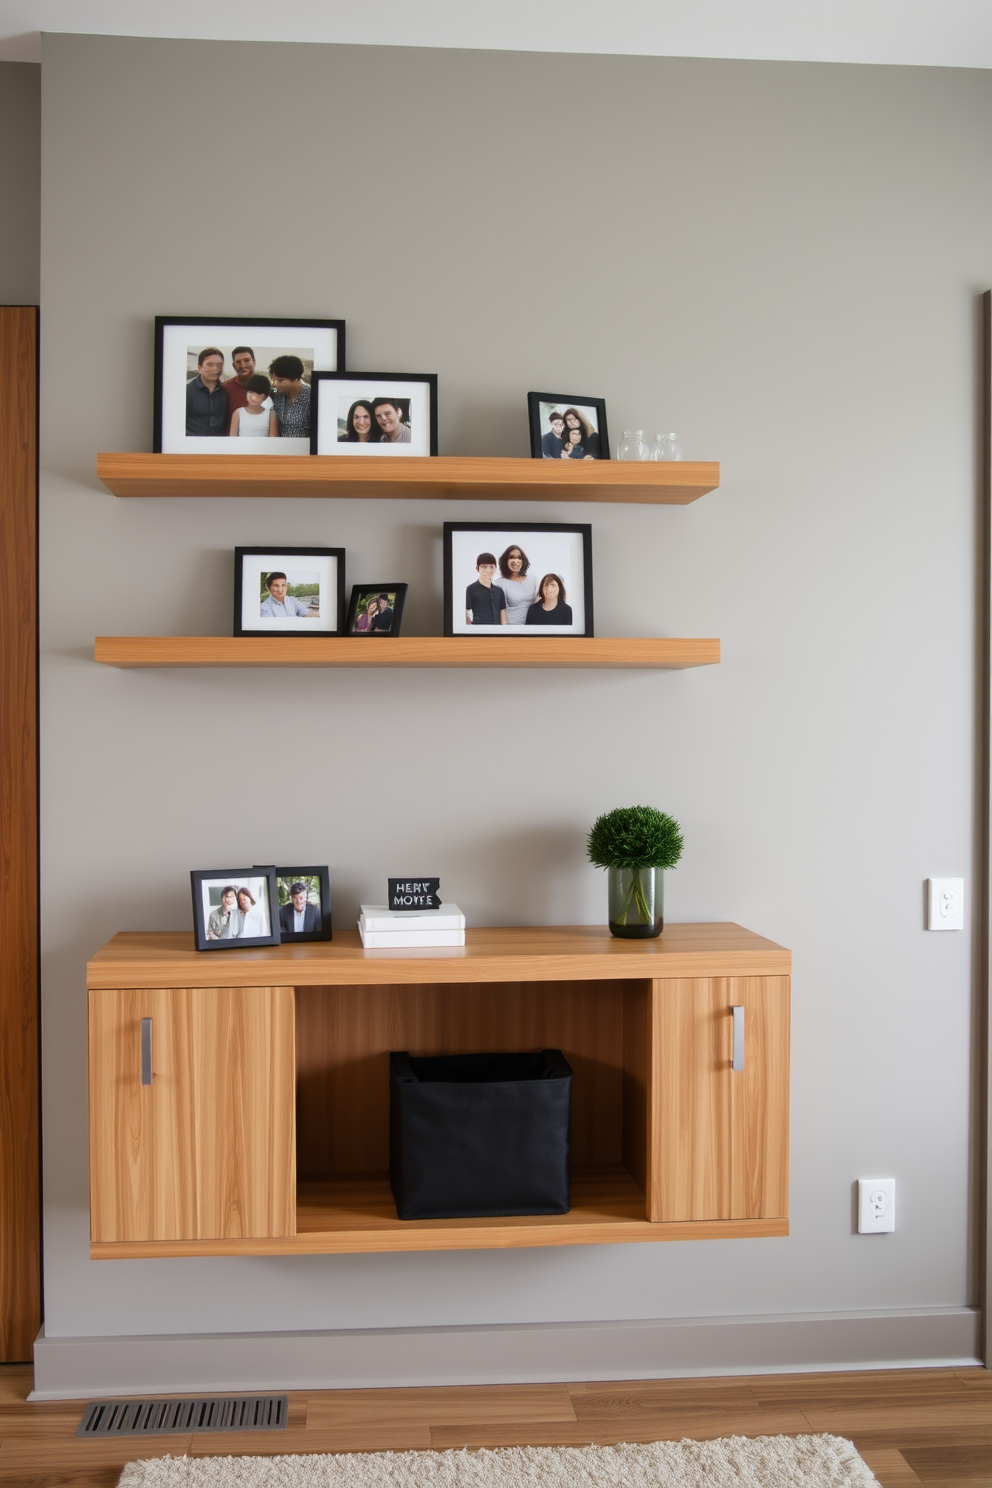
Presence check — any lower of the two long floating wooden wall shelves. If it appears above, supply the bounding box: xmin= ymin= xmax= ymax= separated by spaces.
xmin=94 ymin=635 xmax=720 ymax=670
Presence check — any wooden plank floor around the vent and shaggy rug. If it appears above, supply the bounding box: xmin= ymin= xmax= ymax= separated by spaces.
xmin=0 ymin=1366 xmax=992 ymax=1488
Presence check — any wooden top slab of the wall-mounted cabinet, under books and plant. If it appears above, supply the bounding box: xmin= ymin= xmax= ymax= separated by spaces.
xmin=86 ymin=923 xmax=791 ymax=990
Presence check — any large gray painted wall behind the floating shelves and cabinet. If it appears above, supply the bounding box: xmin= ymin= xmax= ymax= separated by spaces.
xmin=42 ymin=36 xmax=992 ymax=1363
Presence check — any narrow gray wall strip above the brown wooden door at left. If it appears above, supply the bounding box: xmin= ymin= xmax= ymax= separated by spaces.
xmin=0 ymin=62 xmax=42 ymax=305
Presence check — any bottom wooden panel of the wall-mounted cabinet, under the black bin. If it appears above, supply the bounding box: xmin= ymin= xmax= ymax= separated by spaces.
xmin=91 ymin=1167 xmax=788 ymax=1260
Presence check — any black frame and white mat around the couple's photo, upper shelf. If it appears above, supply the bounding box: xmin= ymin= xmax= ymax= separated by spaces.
xmin=309 ymin=369 xmax=437 ymax=458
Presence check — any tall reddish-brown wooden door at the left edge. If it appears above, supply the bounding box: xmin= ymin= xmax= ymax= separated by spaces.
xmin=0 ymin=305 xmax=42 ymax=1360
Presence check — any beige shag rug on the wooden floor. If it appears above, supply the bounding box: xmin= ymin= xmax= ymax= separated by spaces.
xmin=119 ymin=1436 xmax=876 ymax=1488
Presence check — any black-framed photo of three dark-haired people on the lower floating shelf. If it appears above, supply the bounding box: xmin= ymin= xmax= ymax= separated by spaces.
xmin=443 ymin=522 xmax=593 ymax=637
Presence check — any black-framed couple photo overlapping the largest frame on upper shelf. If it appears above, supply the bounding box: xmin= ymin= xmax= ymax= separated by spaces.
xmin=311 ymin=372 xmax=437 ymax=455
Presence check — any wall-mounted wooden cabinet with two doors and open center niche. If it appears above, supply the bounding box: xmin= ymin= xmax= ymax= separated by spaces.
xmin=89 ymin=924 xmax=790 ymax=1257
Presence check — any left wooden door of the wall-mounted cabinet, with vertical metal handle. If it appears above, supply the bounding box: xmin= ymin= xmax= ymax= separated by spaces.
xmin=89 ymin=987 xmax=296 ymax=1241
